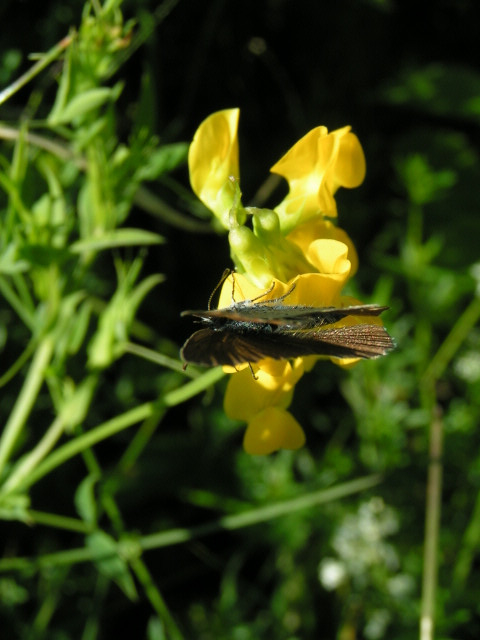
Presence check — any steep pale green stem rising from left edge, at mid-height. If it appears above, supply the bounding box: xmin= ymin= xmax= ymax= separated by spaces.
xmin=0 ymin=335 xmax=54 ymax=474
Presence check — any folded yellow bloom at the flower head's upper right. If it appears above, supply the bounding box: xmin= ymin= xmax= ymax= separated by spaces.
xmin=270 ymin=127 xmax=366 ymax=232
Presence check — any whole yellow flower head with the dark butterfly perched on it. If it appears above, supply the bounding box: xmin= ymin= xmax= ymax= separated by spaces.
xmin=188 ymin=109 xmax=381 ymax=454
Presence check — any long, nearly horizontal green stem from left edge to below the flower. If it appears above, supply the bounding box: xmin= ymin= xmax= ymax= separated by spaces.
xmin=0 ymin=475 xmax=382 ymax=572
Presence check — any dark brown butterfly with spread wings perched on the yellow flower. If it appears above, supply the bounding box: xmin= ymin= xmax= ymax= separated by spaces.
xmin=180 ymin=278 xmax=395 ymax=367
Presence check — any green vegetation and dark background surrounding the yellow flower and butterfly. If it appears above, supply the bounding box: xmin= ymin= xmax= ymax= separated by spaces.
xmin=0 ymin=0 xmax=480 ymax=640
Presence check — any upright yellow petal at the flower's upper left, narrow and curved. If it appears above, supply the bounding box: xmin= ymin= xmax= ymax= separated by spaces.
xmin=188 ymin=109 xmax=240 ymax=222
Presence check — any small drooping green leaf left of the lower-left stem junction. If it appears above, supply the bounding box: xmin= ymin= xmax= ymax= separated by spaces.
xmin=87 ymin=531 xmax=138 ymax=600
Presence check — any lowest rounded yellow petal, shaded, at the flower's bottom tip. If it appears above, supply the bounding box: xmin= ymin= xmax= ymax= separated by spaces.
xmin=243 ymin=407 xmax=305 ymax=455
